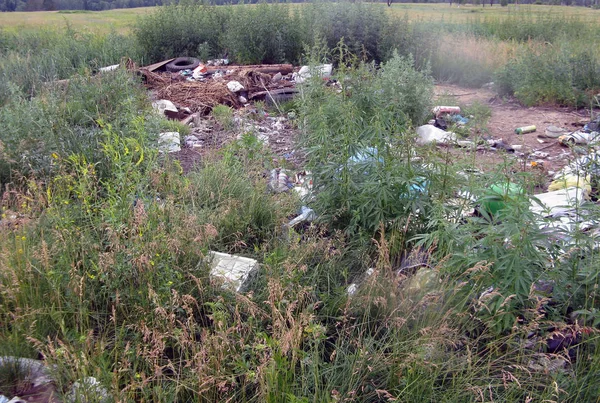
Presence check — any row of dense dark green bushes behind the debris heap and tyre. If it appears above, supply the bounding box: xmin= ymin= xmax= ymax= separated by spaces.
xmin=135 ymin=2 xmax=426 ymax=63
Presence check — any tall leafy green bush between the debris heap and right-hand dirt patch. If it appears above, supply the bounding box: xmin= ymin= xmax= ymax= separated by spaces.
xmin=301 ymin=55 xmax=431 ymax=237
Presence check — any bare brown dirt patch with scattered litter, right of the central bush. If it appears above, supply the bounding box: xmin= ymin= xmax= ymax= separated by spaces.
xmin=435 ymin=85 xmax=590 ymax=172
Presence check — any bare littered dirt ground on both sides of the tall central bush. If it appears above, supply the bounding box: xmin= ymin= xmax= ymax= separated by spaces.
xmin=172 ymin=85 xmax=590 ymax=174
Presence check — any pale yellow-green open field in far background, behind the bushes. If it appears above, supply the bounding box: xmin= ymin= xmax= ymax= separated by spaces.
xmin=0 ymin=3 xmax=600 ymax=33
